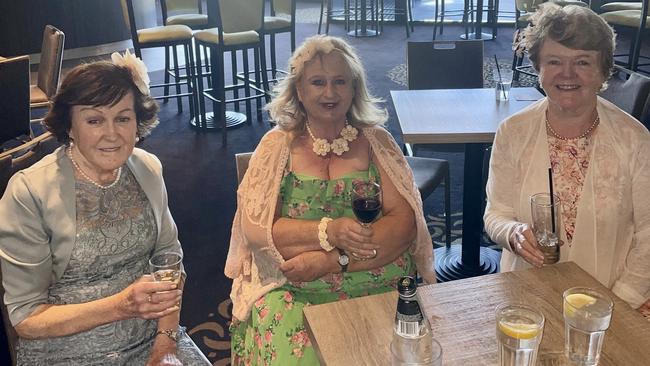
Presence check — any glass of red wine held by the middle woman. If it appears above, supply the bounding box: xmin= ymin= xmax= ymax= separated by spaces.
xmin=352 ymin=181 xmax=381 ymax=260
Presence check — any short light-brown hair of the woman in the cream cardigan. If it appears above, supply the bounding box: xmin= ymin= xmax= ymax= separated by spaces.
xmin=520 ymin=2 xmax=616 ymax=80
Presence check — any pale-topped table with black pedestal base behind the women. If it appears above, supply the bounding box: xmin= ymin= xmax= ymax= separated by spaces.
xmin=390 ymin=88 xmax=542 ymax=281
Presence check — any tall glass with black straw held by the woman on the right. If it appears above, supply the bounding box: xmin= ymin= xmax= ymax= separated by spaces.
xmin=530 ymin=193 xmax=560 ymax=264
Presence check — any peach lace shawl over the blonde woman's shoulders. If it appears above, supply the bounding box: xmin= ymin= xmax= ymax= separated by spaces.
xmin=225 ymin=127 xmax=435 ymax=321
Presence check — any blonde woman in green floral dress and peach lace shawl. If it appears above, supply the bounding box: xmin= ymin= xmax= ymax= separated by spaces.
xmin=225 ymin=36 xmax=435 ymax=366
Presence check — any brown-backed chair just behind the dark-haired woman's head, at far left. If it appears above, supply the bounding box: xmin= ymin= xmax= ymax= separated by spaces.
xmin=29 ymin=25 xmax=65 ymax=121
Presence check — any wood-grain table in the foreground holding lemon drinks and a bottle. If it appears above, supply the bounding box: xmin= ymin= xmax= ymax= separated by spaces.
xmin=304 ymin=262 xmax=650 ymax=366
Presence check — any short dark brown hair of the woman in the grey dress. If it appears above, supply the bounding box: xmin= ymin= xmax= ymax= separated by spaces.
xmin=44 ymin=61 xmax=158 ymax=145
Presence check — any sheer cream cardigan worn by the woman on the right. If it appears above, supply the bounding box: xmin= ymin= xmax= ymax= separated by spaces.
xmin=484 ymin=98 xmax=650 ymax=308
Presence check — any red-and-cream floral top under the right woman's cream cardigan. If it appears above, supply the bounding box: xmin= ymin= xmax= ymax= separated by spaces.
xmin=548 ymin=134 xmax=593 ymax=246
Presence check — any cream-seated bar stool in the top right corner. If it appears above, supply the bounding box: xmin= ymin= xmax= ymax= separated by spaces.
xmin=600 ymin=1 xmax=650 ymax=73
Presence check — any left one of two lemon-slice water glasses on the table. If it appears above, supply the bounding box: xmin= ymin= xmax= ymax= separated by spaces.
xmin=496 ymin=303 xmax=544 ymax=366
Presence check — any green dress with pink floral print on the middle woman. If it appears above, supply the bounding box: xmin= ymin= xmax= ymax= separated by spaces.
xmin=230 ymin=164 xmax=415 ymax=366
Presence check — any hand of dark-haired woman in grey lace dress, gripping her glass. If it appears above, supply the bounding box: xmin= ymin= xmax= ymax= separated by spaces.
xmin=117 ymin=275 xmax=182 ymax=319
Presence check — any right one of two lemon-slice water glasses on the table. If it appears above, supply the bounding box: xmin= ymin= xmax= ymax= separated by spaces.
xmin=563 ymin=287 xmax=614 ymax=365
